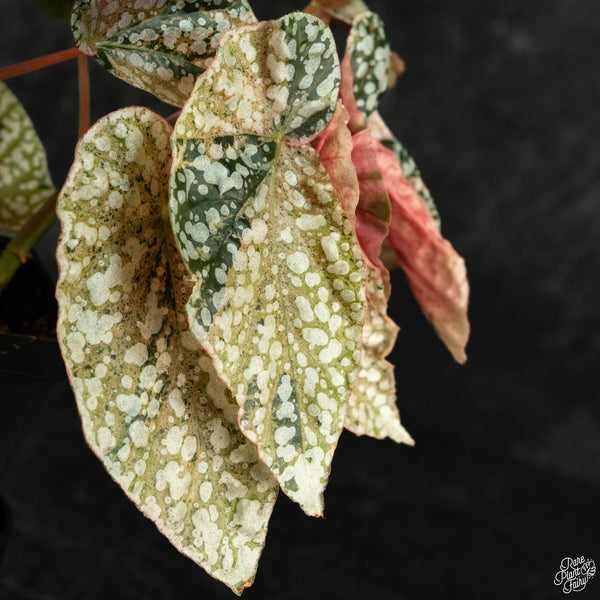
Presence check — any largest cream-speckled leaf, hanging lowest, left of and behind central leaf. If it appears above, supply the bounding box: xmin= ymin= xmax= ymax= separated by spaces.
xmin=57 ymin=108 xmax=277 ymax=593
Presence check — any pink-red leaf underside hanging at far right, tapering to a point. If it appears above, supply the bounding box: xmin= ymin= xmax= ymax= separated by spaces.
xmin=376 ymin=142 xmax=470 ymax=363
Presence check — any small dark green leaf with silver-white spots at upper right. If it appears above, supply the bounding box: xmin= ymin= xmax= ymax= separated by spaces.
xmin=345 ymin=11 xmax=392 ymax=117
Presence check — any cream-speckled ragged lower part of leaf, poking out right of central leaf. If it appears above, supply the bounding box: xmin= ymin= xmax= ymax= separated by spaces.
xmin=345 ymin=265 xmax=414 ymax=446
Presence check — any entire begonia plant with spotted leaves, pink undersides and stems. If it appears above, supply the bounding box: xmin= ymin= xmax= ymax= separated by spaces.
xmin=0 ymin=0 xmax=469 ymax=594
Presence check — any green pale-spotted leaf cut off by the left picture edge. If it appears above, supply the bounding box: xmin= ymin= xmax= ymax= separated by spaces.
xmin=0 ymin=81 xmax=54 ymax=232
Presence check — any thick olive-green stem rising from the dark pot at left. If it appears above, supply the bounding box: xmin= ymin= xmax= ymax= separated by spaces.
xmin=0 ymin=191 xmax=58 ymax=294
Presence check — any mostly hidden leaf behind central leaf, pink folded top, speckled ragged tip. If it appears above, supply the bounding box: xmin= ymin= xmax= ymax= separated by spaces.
xmin=313 ymin=110 xmax=413 ymax=444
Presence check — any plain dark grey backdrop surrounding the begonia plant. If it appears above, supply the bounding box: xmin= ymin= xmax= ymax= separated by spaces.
xmin=0 ymin=0 xmax=600 ymax=600
